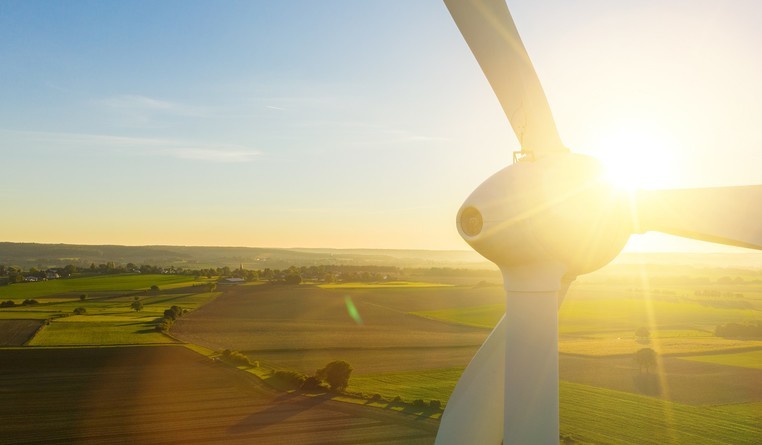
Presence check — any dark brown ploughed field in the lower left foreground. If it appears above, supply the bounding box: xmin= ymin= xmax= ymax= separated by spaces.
xmin=0 ymin=346 xmax=437 ymax=444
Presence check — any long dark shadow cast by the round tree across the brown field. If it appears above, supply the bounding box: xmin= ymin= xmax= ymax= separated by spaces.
xmin=228 ymin=393 xmax=331 ymax=434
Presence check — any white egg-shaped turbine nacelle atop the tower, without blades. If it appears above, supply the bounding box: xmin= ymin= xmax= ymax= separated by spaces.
xmin=457 ymin=153 xmax=633 ymax=278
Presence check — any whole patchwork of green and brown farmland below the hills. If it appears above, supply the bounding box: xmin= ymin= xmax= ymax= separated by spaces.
xmin=0 ymin=262 xmax=762 ymax=444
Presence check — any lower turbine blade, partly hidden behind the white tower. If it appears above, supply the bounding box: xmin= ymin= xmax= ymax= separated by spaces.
xmin=435 ymin=316 xmax=506 ymax=445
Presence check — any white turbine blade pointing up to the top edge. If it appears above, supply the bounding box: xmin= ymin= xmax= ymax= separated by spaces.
xmin=444 ymin=0 xmax=569 ymax=155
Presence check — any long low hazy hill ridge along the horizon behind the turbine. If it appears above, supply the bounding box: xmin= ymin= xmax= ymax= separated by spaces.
xmin=0 ymin=242 xmax=762 ymax=269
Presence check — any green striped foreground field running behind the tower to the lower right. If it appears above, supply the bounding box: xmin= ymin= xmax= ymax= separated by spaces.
xmin=352 ymin=369 xmax=762 ymax=445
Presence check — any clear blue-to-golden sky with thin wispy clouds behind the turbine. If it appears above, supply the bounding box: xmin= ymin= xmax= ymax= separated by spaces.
xmin=0 ymin=0 xmax=762 ymax=250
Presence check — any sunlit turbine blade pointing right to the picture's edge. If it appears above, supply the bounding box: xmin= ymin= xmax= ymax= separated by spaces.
xmin=634 ymin=185 xmax=762 ymax=250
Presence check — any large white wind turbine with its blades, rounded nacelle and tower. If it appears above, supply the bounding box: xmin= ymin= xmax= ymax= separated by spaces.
xmin=436 ymin=0 xmax=762 ymax=445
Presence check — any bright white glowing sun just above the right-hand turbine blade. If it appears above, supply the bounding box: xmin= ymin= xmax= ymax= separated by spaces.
xmin=595 ymin=120 xmax=675 ymax=190
